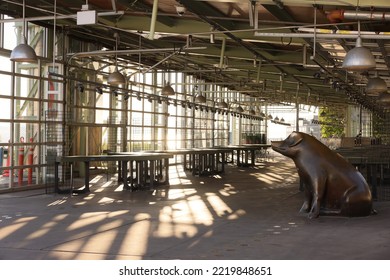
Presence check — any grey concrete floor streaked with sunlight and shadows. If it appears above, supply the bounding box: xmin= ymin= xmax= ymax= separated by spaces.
xmin=0 ymin=157 xmax=390 ymax=260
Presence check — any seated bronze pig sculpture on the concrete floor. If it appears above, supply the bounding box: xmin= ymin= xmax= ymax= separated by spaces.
xmin=271 ymin=132 xmax=375 ymax=218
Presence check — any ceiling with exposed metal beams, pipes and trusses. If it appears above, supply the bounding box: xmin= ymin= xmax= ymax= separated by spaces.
xmin=0 ymin=0 xmax=390 ymax=114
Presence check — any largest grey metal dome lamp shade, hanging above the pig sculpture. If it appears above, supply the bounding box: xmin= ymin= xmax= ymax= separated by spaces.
xmin=342 ymin=37 xmax=376 ymax=72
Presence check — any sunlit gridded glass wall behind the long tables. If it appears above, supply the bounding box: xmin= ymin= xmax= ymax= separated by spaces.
xmin=0 ymin=14 xmax=263 ymax=190
